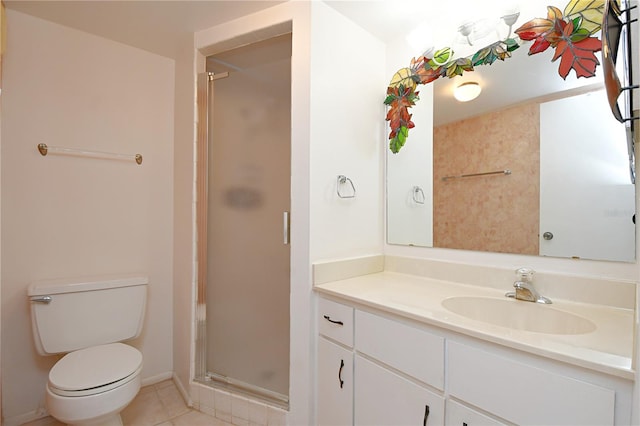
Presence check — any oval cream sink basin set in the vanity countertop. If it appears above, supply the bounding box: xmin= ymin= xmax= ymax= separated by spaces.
xmin=442 ymin=296 xmax=596 ymax=334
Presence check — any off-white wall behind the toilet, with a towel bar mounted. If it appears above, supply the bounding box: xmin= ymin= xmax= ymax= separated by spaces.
xmin=2 ymin=10 xmax=174 ymax=424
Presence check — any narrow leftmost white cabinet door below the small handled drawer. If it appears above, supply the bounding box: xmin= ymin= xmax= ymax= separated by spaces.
xmin=318 ymin=337 xmax=353 ymax=426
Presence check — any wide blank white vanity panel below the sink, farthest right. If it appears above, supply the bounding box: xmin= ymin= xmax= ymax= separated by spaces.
xmin=447 ymin=341 xmax=615 ymax=425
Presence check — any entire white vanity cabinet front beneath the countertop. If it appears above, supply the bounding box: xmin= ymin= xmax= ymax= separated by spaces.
xmin=318 ymin=297 xmax=633 ymax=426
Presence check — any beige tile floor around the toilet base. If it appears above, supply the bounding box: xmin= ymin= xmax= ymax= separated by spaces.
xmin=25 ymin=380 xmax=233 ymax=426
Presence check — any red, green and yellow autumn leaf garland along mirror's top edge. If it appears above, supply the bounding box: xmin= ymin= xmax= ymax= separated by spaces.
xmin=384 ymin=0 xmax=604 ymax=154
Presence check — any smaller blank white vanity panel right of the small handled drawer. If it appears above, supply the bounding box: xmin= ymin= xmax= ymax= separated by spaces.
xmin=355 ymin=310 xmax=444 ymax=390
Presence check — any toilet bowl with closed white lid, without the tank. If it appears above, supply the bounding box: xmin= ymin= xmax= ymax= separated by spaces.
xmin=46 ymin=343 xmax=142 ymax=426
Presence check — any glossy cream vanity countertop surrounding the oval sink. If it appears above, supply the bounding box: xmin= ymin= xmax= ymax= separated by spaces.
xmin=314 ymin=271 xmax=634 ymax=380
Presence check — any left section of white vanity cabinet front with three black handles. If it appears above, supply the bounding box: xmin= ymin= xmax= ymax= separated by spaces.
xmin=317 ymin=298 xmax=444 ymax=426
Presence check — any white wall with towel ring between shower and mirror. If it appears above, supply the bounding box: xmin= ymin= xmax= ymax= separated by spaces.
xmin=308 ymin=2 xmax=386 ymax=262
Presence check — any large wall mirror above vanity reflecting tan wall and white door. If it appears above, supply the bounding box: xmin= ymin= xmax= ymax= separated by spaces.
xmin=387 ymin=0 xmax=635 ymax=262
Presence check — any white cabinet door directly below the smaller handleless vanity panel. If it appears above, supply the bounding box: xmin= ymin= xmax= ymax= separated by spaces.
xmin=354 ymin=355 xmax=444 ymax=426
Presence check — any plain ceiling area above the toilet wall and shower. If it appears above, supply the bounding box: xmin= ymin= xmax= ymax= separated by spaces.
xmin=4 ymin=0 xmax=284 ymax=58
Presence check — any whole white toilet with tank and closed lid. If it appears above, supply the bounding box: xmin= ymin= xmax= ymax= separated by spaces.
xmin=27 ymin=275 xmax=149 ymax=426
